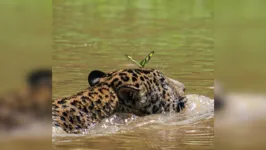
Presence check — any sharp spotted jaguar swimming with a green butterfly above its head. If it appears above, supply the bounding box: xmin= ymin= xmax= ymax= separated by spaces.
xmin=52 ymin=69 xmax=187 ymax=133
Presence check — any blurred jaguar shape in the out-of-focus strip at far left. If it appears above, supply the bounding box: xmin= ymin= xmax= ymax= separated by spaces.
xmin=0 ymin=68 xmax=52 ymax=132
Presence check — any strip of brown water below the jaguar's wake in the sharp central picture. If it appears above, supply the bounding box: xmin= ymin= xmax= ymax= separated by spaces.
xmin=53 ymin=120 xmax=214 ymax=150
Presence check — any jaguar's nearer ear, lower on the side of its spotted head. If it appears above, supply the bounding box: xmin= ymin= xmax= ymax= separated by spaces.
xmin=117 ymin=86 xmax=139 ymax=101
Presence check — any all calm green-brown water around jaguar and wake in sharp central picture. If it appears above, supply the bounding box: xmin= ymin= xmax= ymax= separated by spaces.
xmin=53 ymin=0 xmax=214 ymax=150
